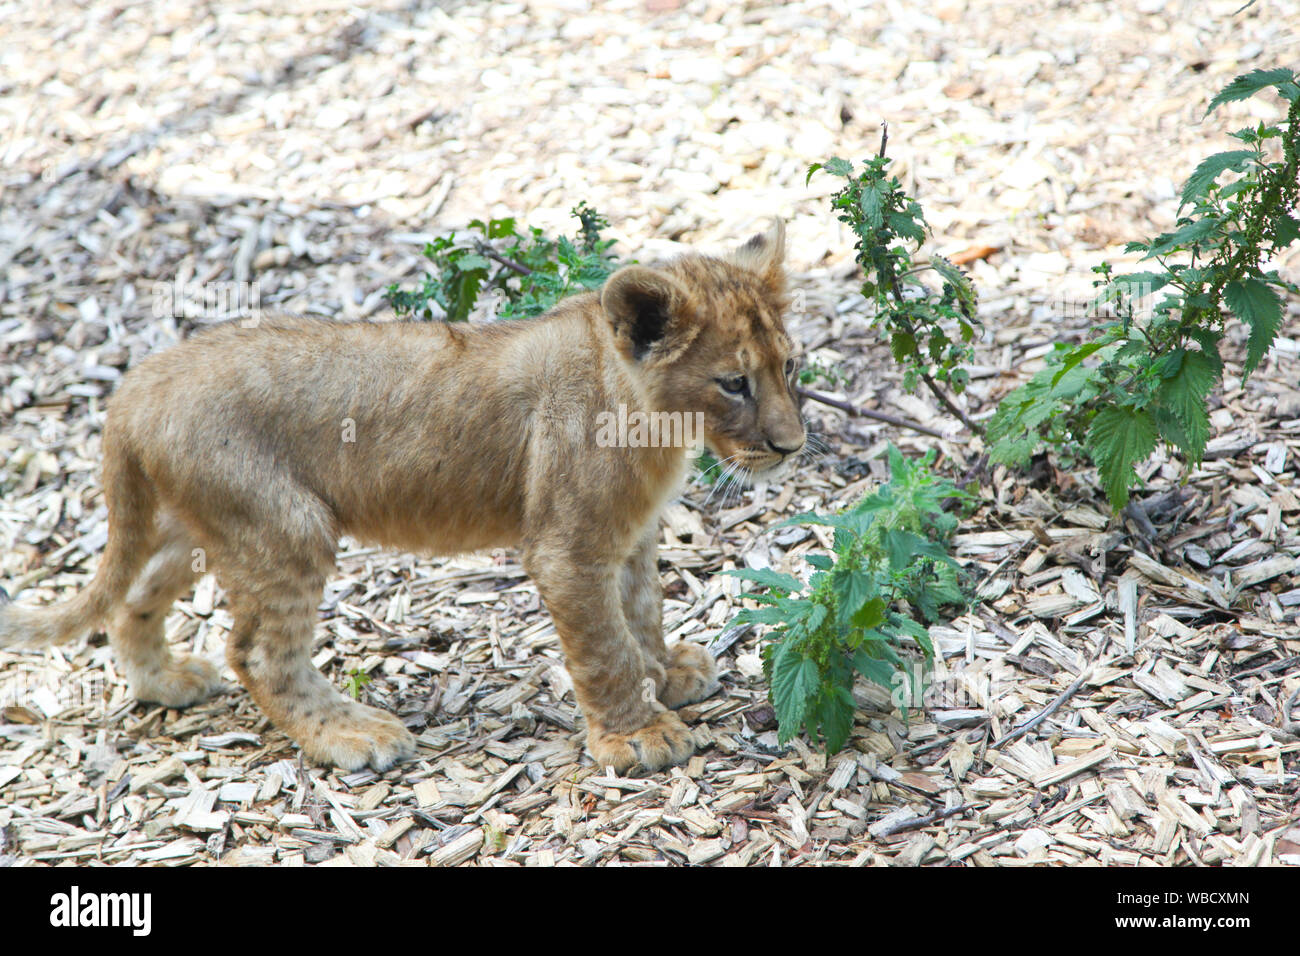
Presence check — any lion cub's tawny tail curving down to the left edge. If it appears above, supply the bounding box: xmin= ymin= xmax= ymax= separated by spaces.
xmin=0 ymin=433 xmax=157 ymax=648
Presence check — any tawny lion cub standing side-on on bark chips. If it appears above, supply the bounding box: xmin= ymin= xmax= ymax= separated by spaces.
xmin=0 ymin=225 xmax=805 ymax=771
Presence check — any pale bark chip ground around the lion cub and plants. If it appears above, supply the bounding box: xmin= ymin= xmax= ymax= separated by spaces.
xmin=0 ymin=0 xmax=1300 ymax=866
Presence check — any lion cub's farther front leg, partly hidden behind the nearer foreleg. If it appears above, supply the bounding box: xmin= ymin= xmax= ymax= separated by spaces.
xmin=620 ymin=524 xmax=718 ymax=708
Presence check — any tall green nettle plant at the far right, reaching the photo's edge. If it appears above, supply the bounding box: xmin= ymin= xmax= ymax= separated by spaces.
xmin=985 ymin=69 xmax=1300 ymax=511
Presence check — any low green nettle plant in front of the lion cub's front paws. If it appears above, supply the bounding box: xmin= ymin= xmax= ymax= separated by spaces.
xmin=727 ymin=445 xmax=966 ymax=753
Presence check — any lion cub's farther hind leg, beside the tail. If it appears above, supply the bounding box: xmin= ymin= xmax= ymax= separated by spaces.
xmin=108 ymin=512 xmax=221 ymax=708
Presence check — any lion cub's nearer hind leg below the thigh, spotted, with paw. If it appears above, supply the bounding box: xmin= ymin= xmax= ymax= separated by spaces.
xmin=217 ymin=535 xmax=415 ymax=771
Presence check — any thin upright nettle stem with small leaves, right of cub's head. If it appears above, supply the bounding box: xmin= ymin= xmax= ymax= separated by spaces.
xmin=807 ymin=152 xmax=979 ymax=431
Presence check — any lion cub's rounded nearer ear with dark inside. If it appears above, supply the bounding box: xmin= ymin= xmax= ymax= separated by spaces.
xmin=601 ymin=265 xmax=699 ymax=362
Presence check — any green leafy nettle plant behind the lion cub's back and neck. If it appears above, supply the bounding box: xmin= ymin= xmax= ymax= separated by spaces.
xmin=385 ymin=202 xmax=621 ymax=323
